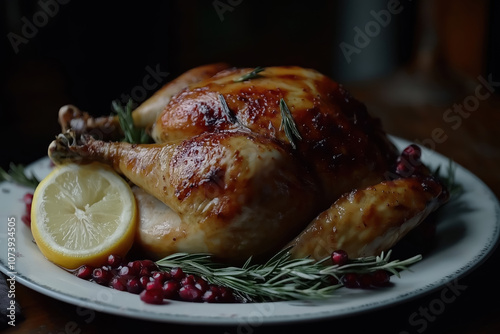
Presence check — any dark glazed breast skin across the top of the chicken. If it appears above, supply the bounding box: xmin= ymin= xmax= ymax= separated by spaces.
xmin=152 ymin=66 xmax=396 ymax=205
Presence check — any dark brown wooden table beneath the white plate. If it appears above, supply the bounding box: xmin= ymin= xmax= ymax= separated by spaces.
xmin=1 ymin=72 xmax=500 ymax=334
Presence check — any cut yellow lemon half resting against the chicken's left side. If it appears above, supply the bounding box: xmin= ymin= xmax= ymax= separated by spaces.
xmin=31 ymin=163 xmax=137 ymax=269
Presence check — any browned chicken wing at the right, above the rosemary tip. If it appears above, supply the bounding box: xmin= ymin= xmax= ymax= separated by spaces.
xmin=289 ymin=177 xmax=447 ymax=260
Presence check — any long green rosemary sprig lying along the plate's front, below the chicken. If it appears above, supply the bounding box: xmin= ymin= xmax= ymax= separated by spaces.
xmin=157 ymin=249 xmax=422 ymax=302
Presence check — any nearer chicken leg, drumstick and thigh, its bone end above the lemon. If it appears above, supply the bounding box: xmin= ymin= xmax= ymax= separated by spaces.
xmin=50 ymin=131 xmax=319 ymax=262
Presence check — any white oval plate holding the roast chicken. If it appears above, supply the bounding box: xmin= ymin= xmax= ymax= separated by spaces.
xmin=0 ymin=138 xmax=500 ymax=325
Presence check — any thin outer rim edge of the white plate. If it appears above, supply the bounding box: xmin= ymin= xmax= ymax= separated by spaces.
xmin=0 ymin=135 xmax=500 ymax=325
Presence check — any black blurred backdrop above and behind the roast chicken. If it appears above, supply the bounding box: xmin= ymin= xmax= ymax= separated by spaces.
xmin=0 ymin=0 xmax=499 ymax=168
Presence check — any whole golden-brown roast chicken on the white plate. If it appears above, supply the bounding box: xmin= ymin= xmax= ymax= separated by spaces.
xmin=49 ymin=64 xmax=448 ymax=263
